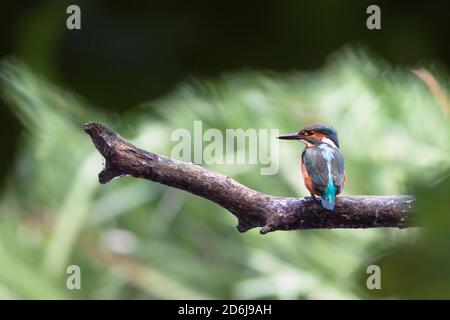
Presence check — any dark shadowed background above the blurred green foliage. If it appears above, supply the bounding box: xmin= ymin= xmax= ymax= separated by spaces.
xmin=0 ymin=0 xmax=450 ymax=185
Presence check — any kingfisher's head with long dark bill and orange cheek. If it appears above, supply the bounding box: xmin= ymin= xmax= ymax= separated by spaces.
xmin=278 ymin=124 xmax=339 ymax=148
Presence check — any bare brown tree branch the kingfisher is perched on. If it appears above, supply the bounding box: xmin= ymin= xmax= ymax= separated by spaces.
xmin=84 ymin=123 xmax=414 ymax=234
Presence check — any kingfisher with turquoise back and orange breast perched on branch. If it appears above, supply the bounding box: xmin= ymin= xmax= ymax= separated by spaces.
xmin=278 ymin=124 xmax=346 ymax=211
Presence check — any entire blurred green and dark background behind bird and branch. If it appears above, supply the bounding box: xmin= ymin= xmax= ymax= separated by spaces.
xmin=0 ymin=0 xmax=450 ymax=299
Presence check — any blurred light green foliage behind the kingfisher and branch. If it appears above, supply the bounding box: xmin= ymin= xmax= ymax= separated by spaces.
xmin=0 ymin=50 xmax=450 ymax=299
